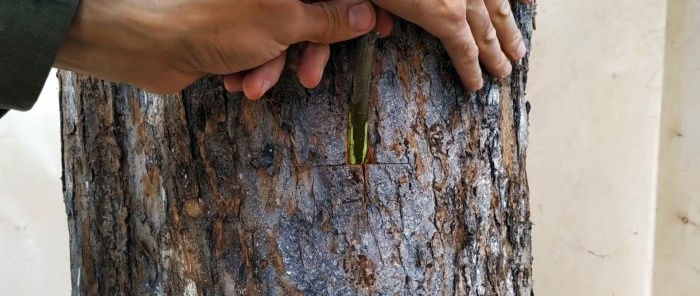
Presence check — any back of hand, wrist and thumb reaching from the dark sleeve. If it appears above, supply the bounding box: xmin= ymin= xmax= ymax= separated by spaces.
xmin=55 ymin=0 xmax=376 ymax=93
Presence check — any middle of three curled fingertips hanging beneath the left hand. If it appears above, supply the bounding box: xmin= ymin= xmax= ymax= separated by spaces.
xmin=241 ymin=52 xmax=286 ymax=100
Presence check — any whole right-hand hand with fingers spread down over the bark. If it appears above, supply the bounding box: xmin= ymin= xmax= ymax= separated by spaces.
xmin=372 ymin=0 xmax=533 ymax=90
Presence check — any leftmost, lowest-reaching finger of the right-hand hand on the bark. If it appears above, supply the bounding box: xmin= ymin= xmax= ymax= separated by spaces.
xmin=441 ymin=24 xmax=484 ymax=90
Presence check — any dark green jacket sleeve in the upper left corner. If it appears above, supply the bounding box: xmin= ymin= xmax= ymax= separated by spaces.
xmin=0 ymin=0 xmax=79 ymax=116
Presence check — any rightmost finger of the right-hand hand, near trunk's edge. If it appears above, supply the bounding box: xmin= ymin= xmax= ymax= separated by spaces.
xmin=484 ymin=0 xmax=527 ymax=61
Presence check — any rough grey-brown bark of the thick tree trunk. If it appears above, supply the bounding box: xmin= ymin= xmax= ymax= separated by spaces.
xmin=59 ymin=5 xmax=533 ymax=296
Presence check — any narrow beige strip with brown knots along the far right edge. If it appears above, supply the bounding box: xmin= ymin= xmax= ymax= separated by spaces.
xmin=654 ymin=0 xmax=700 ymax=296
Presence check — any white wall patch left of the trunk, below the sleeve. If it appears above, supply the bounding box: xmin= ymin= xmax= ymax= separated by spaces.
xmin=0 ymin=73 xmax=70 ymax=296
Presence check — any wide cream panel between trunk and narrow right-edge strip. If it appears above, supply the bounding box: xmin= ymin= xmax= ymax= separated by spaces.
xmin=527 ymin=0 xmax=666 ymax=296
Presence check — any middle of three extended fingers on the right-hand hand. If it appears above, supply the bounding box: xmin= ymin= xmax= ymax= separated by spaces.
xmin=467 ymin=0 xmax=512 ymax=78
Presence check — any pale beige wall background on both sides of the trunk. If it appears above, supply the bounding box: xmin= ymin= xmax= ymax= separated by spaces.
xmin=0 ymin=0 xmax=700 ymax=296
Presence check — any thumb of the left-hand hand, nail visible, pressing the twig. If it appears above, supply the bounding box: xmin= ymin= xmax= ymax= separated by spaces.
xmin=297 ymin=0 xmax=376 ymax=44
